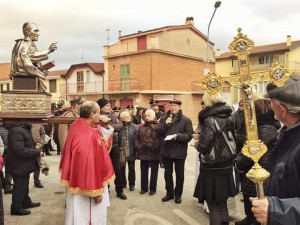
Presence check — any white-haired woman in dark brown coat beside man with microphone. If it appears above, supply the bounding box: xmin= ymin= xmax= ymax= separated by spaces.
xmin=134 ymin=109 xmax=161 ymax=195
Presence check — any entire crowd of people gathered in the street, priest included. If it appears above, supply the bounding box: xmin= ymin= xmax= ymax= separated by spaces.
xmin=0 ymin=76 xmax=300 ymax=225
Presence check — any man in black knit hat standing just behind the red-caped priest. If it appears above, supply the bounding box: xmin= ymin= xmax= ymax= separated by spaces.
xmin=97 ymin=98 xmax=127 ymax=200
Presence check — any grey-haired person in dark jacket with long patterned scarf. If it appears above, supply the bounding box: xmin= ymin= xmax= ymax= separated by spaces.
xmin=118 ymin=111 xmax=137 ymax=191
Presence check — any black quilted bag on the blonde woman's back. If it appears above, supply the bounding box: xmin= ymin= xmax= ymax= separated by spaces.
xmin=201 ymin=118 xmax=236 ymax=164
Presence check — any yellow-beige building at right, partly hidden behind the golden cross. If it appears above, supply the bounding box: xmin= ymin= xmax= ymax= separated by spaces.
xmin=216 ymin=35 xmax=300 ymax=104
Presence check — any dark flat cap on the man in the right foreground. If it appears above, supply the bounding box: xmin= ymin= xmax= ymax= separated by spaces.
xmin=264 ymin=75 xmax=300 ymax=105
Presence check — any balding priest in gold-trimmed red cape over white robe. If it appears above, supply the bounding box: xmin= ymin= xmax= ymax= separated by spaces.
xmin=59 ymin=101 xmax=114 ymax=225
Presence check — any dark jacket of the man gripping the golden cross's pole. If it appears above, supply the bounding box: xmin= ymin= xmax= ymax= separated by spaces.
xmin=265 ymin=120 xmax=300 ymax=225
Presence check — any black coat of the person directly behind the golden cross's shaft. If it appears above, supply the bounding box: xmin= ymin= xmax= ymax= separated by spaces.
xmin=236 ymin=111 xmax=280 ymax=197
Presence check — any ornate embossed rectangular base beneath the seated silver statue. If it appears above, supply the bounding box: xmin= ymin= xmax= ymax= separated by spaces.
xmin=0 ymin=90 xmax=53 ymax=124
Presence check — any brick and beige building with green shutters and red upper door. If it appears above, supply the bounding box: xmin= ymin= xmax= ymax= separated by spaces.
xmin=103 ymin=17 xmax=215 ymax=124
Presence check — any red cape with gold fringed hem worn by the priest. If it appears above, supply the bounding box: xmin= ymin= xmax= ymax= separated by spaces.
xmin=59 ymin=118 xmax=114 ymax=197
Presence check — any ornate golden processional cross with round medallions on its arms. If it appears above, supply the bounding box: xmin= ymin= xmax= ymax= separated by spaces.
xmin=201 ymin=28 xmax=290 ymax=199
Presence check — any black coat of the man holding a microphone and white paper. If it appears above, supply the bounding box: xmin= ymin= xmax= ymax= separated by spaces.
xmin=156 ymin=110 xmax=193 ymax=159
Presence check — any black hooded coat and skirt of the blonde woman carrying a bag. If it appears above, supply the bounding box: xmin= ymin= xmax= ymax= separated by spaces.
xmin=193 ymin=103 xmax=237 ymax=203
